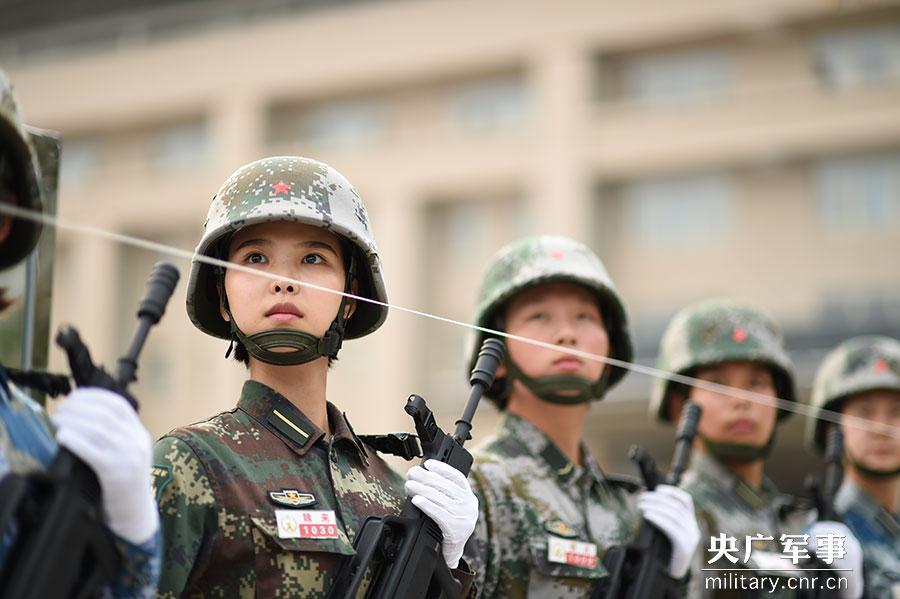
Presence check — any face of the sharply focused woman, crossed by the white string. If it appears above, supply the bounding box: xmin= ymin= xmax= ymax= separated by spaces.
xmin=223 ymin=222 xmax=353 ymax=351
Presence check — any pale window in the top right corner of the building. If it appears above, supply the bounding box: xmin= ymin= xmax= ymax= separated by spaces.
xmin=813 ymin=25 xmax=900 ymax=90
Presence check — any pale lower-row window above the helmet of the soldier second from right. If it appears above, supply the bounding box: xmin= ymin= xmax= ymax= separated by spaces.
xmin=623 ymin=174 xmax=734 ymax=246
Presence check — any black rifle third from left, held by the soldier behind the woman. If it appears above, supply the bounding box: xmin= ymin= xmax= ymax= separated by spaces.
xmin=592 ymin=402 xmax=700 ymax=599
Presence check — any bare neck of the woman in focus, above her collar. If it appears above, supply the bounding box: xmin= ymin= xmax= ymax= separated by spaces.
xmin=250 ymin=357 xmax=331 ymax=437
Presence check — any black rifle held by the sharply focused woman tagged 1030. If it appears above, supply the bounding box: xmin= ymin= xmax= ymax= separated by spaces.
xmin=330 ymin=339 xmax=504 ymax=599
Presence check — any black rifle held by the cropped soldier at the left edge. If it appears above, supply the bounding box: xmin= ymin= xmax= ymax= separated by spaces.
xmin=0 ymin=262 xmax=179 ymax=599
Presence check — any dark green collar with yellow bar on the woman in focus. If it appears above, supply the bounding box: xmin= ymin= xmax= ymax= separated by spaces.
xmin=238 ymin=380 xmax=368 ymax=465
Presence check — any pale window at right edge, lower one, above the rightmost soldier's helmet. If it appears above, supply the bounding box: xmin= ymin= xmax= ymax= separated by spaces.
xmin=813 ymin=152 xmax=900 ymax=230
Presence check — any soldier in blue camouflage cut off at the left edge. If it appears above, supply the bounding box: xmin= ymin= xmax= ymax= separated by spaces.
xmin=0 ymin=71 xmax=160 ymax=597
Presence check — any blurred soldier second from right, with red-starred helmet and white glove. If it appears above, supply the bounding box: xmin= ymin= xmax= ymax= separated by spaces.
xmin=650 ymin=300 xmax=862 ymax=599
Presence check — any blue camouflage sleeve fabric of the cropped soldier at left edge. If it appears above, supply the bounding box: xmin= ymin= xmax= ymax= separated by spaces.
xmin=0 ymin=367 xmax=162 ymax=598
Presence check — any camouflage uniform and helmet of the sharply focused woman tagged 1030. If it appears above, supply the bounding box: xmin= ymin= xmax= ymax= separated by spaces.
xmin=154 ymin=156 xmax=472 ymax=597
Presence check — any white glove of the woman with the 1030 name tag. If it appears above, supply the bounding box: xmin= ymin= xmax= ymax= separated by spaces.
xmin=406 ymin=460 xmax=478 ymax=568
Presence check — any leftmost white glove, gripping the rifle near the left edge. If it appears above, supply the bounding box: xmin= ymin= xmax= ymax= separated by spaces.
xmin=52 ymin=387 xmax=159 ymax=545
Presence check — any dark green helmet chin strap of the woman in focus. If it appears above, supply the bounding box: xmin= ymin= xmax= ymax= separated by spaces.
xmin=219 ymin=252 xmax=356 ymax=366
